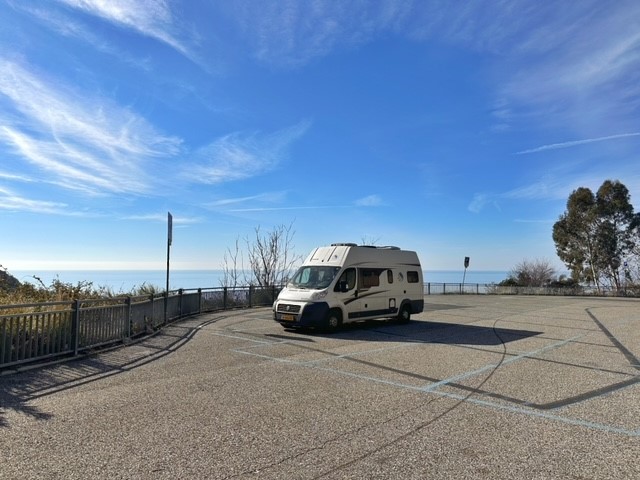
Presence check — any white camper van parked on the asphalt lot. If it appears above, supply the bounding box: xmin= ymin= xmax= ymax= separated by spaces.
xmin=273 ymin=243 xmax=424 ymax=329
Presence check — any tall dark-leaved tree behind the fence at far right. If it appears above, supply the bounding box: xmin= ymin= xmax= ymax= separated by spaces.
xmin=553 ymin=180 xmax=640 ymax=290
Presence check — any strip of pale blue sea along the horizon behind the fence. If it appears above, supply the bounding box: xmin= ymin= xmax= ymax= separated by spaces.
xmin=9 ymin=269 xmax=509 ymax=294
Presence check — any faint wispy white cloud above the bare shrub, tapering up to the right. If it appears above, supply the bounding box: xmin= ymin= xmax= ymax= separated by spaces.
xmin=185 ymin=121 xmax=310 ymax=184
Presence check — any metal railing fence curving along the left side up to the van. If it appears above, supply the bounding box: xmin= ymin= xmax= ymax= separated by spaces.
xmin=0 ymin=287 xmax=279 ymax=369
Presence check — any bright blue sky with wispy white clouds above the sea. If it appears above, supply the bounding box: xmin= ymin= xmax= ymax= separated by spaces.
xmin=0 ymin=0 xmax=640 ymax=274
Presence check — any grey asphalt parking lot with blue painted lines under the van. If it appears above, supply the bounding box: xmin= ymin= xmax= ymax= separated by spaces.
xmin=0 ymin=295 xmax=640 ymax=479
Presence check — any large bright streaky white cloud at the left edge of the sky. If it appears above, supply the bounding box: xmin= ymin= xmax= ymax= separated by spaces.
xmin=0 ymin=59 xmax=181 ymax=194
